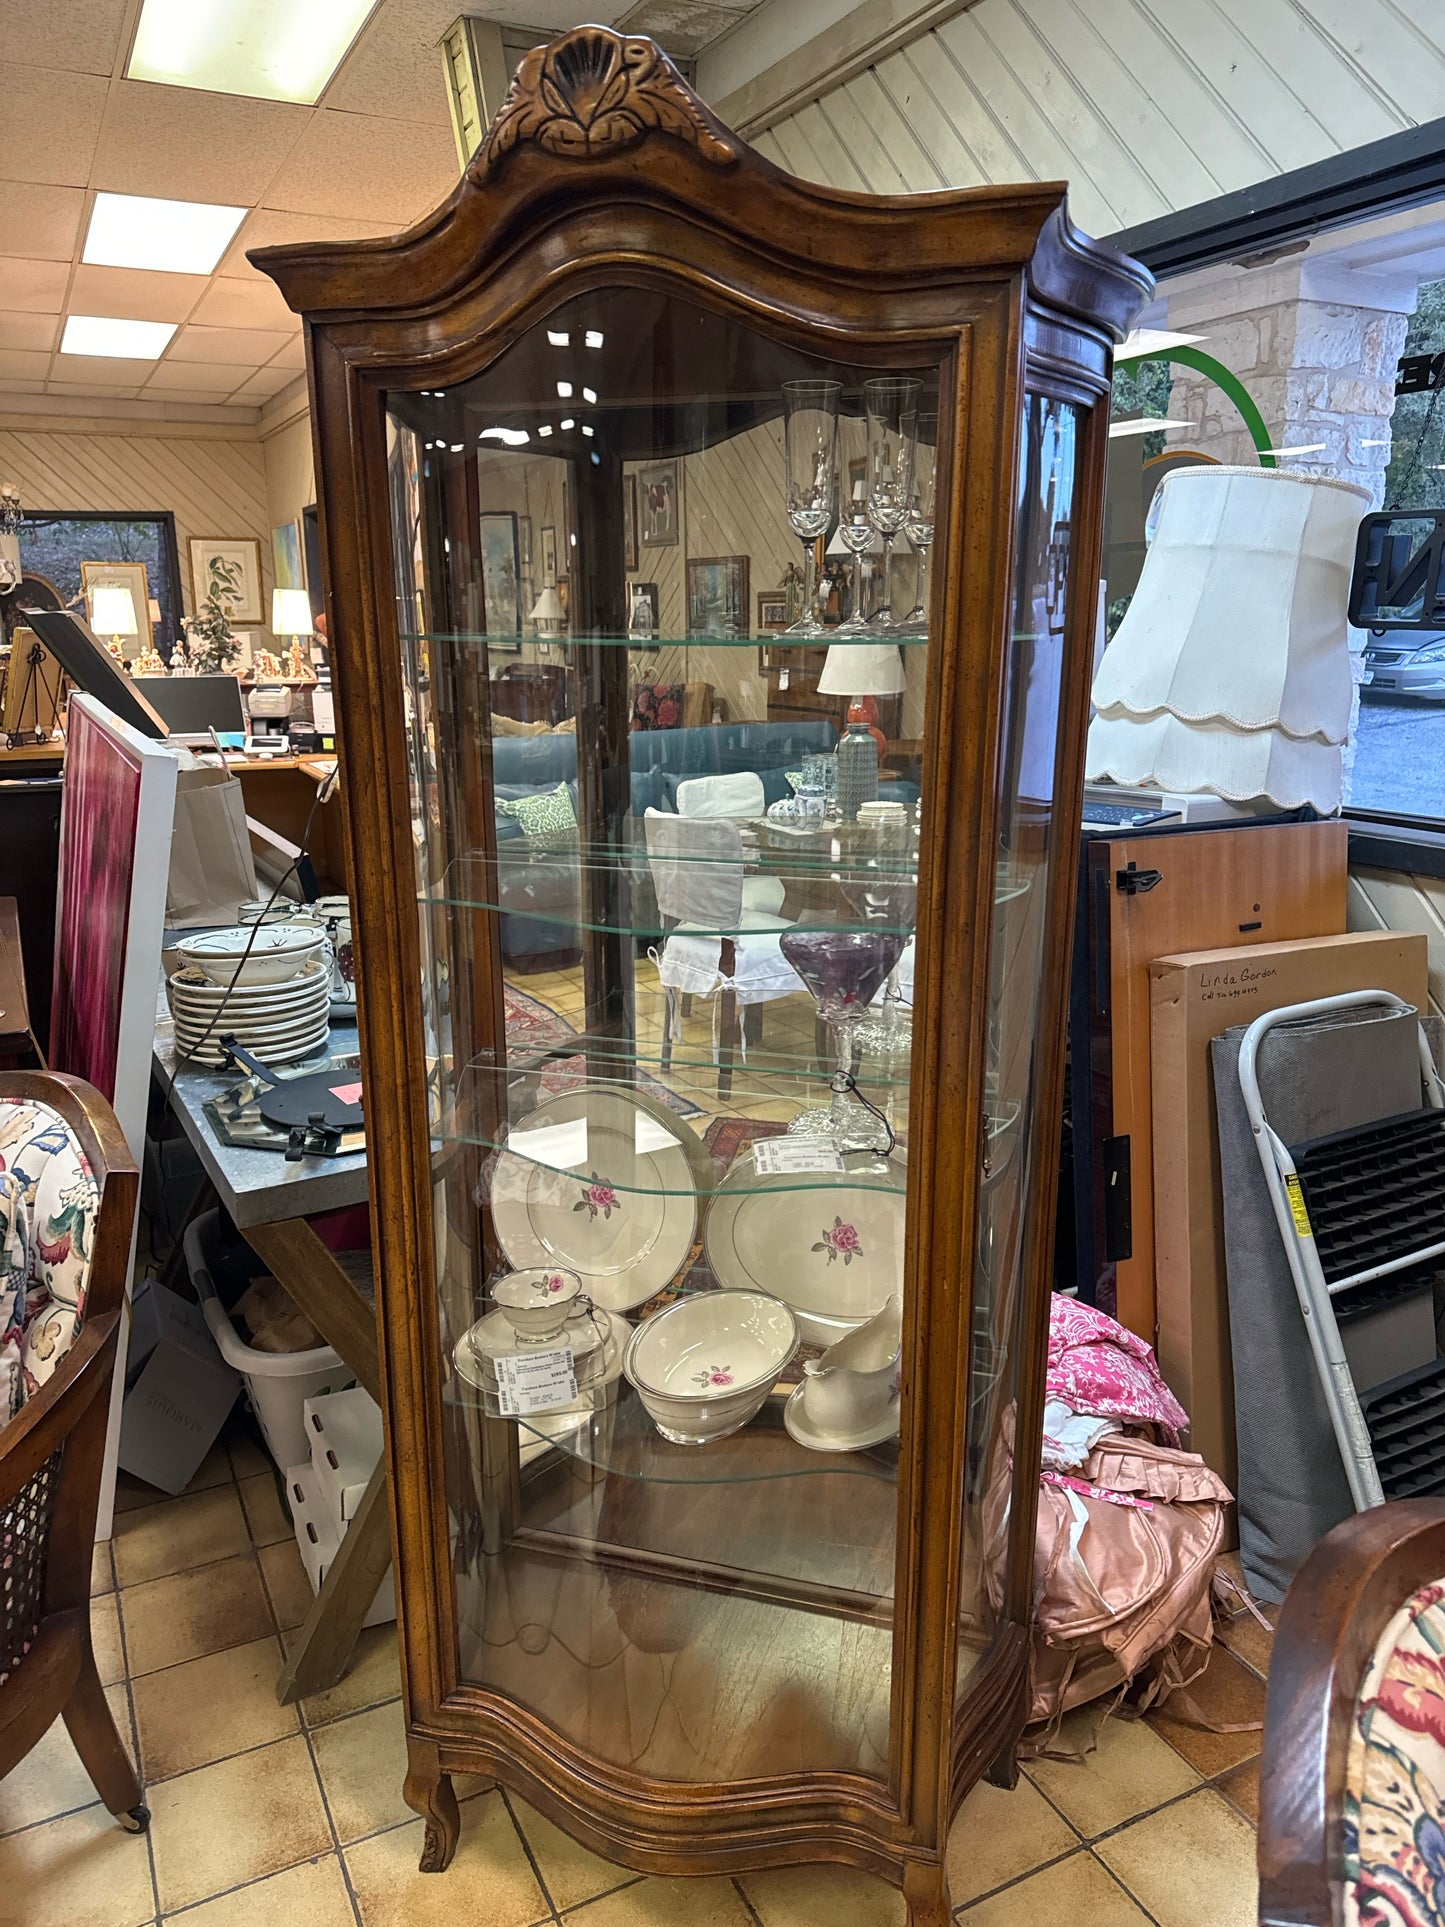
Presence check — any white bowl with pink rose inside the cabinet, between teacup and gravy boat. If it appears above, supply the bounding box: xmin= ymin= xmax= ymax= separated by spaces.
xmin=622 ymin=1291 xmax=798 ymax=1445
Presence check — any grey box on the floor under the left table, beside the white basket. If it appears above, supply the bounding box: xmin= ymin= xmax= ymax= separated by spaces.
xmin=119 ymin=1278 xmax=241 ymax=1493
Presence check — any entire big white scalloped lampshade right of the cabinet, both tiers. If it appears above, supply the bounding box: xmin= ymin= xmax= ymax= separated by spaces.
xmin=1087 ymin=464 xmax=1370 ymax=811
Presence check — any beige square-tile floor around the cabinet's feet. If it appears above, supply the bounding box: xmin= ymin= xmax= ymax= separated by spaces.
xmin=0 ymin=1420 xmax=1268 ymax=1927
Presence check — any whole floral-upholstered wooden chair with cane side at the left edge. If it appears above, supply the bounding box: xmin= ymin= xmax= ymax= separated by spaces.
xmin=0 ymin=1071 xmax=150 ymax=1833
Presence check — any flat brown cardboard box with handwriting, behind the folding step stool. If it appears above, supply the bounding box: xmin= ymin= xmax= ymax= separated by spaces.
xmin=1150 ymin=931 xmax=1430 ymax=1490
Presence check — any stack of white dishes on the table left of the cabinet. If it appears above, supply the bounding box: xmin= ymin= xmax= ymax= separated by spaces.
xmin=166 ymin=923 xmax=331 ymax=1068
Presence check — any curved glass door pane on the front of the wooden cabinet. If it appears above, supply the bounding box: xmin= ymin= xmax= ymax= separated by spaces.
xmin=387 ymin=289 xmax=942 ymax=1781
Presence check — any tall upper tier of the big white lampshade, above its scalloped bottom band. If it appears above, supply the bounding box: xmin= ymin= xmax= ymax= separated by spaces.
xmin=1092 ymin=466 xmax=1370 ymax=743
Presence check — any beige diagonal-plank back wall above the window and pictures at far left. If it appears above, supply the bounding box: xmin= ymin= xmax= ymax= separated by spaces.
xmin=0 ymin=416 xmax=272 ymax=613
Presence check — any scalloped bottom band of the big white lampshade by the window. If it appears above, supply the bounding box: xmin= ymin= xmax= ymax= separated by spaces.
xmin=1085 ymin=709 xmax=1345 ymax=815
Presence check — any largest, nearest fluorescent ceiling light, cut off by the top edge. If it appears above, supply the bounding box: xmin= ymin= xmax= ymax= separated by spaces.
xmin=125 ymin=0 xmax=378 ymax=106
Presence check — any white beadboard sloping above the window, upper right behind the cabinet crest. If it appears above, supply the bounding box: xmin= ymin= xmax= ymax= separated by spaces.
xmin=746 ymin=0 xmax=1445 ymax=235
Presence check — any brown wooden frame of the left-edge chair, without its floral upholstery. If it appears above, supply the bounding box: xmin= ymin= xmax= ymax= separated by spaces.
xmin=0 ymin=1071 xmax=150 ymax=1833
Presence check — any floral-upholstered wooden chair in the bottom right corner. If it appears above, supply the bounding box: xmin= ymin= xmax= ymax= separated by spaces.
xmin=1258 ymin=1499 xmax=1445 ymax=1927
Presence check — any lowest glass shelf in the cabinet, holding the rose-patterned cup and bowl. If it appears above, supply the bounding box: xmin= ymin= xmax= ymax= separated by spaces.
xmin=443 ymin=1368 xmax=898 ymax=1486
